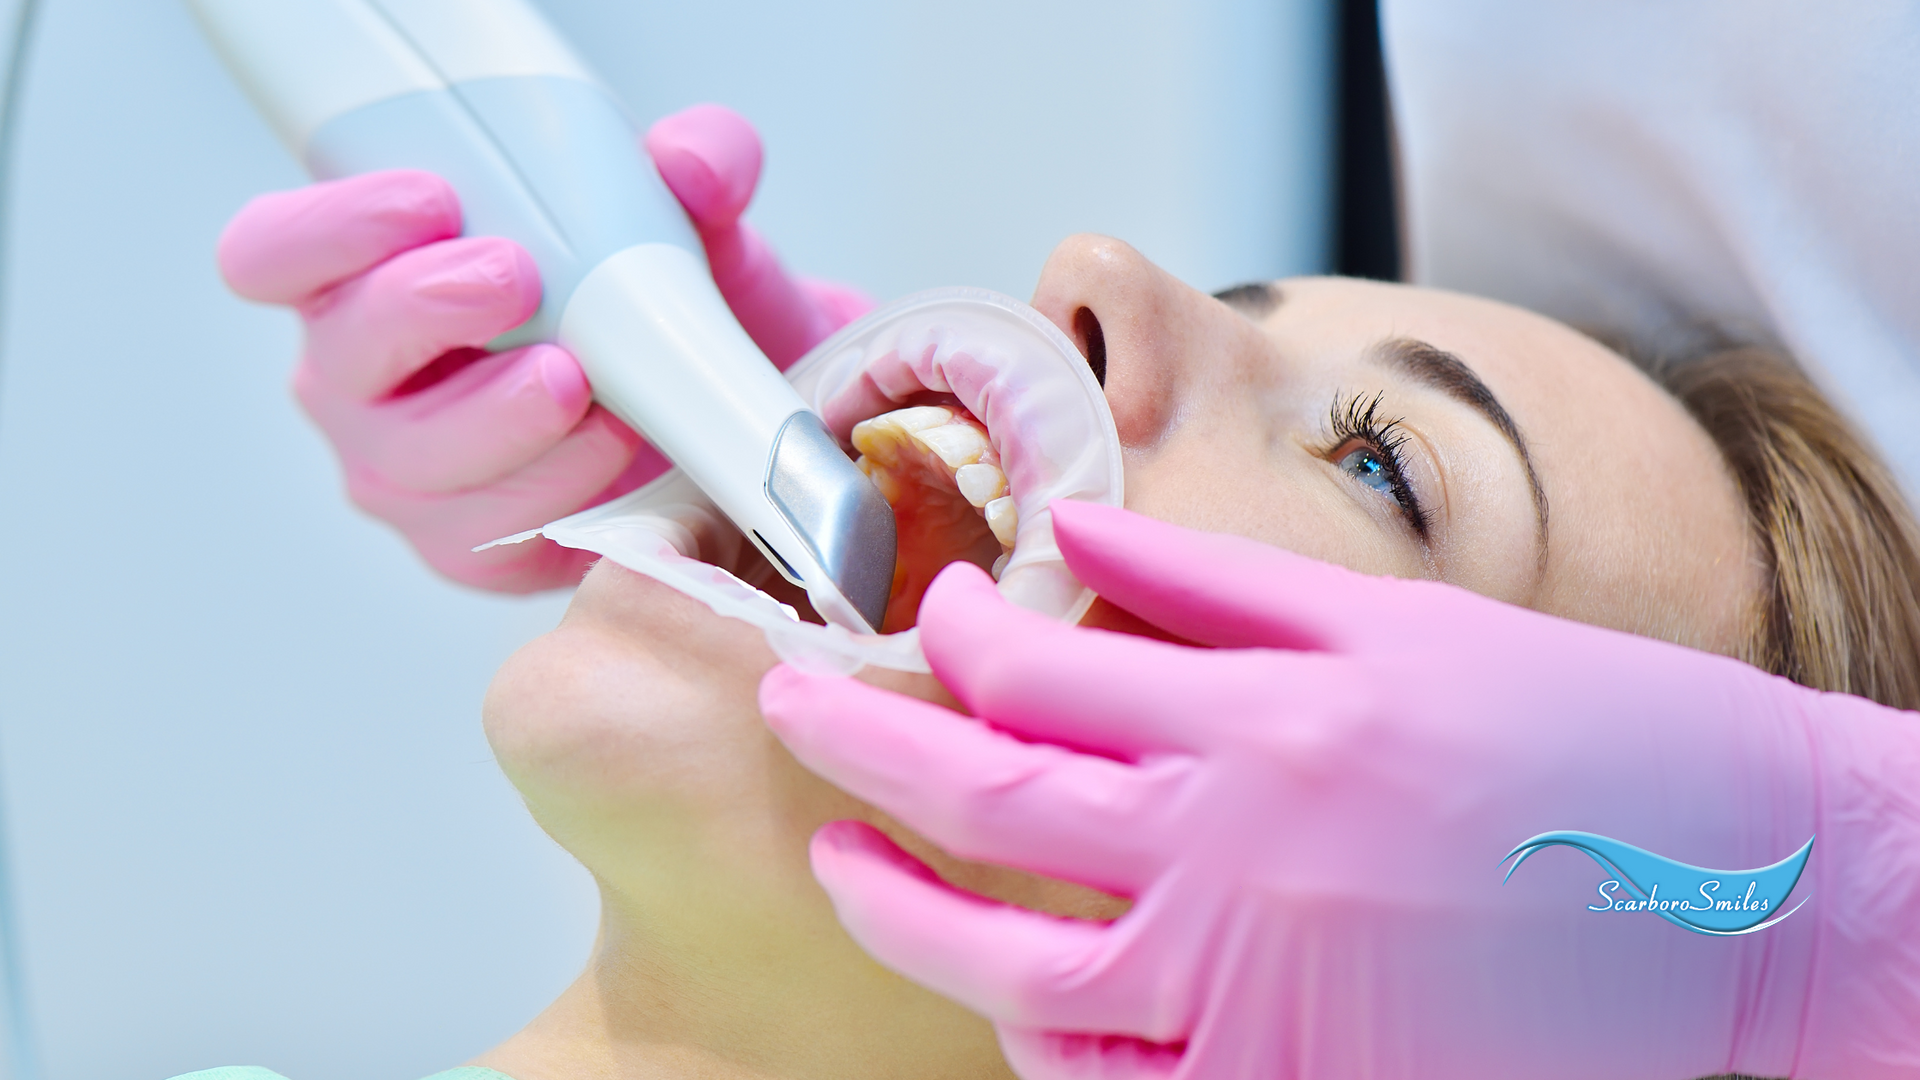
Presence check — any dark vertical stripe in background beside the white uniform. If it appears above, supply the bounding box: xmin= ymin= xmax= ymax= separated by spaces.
xmin=1334 ymin=0 xmax=1400 ymax=281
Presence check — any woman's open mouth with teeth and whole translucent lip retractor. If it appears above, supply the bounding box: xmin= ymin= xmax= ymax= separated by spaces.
xmin=509 ymin=288 xmax=1123 ymax=675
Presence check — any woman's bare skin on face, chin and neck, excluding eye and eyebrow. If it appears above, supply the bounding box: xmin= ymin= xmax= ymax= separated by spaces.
xmin=478 ymin=236 xmax=1761 ymax=1080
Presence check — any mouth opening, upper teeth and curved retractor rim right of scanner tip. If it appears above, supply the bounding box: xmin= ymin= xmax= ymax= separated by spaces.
xmin=789 ymin=288 xmax=1123 ymax=632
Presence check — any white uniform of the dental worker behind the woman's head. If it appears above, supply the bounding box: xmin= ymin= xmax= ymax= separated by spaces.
xmin=1382 ymin=0 xmax=1920 ymax=496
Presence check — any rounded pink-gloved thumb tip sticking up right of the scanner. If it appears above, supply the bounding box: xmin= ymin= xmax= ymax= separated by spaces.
xmin=643 ymin=104 xmax=760 ymax=233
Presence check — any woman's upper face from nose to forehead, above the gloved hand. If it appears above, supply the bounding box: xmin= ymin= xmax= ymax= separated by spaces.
xmin=1035 ymin=238 xmax=1759 ymax=651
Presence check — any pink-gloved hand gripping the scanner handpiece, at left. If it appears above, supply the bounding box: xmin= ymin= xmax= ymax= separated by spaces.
xmin=219 ymin=106 xmax=872 ymax=592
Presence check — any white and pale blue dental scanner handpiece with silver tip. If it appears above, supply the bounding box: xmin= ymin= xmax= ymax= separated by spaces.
xmin=188 ymin=0 xmax=895 ymax=632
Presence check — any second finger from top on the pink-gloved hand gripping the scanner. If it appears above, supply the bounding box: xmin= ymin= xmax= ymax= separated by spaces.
xmin=305 ymin=236 xmax=540 ymax=400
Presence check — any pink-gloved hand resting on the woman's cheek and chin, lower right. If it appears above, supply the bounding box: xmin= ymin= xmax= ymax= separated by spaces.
xmin=760 ymin=503 xmax=1920 ymax=1080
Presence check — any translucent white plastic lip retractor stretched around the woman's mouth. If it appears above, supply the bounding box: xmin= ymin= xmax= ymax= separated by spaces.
xmin=486 ymin=288 xmax=1123 ymax=675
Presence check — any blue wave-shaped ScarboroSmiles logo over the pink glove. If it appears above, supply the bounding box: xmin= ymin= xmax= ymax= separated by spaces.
xmin=1501 ymin=830 xmax=1812 ymax=938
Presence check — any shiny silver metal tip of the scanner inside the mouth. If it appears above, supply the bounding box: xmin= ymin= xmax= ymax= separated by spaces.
xmin=766 ymin=411 xmax=900 ymax=634
